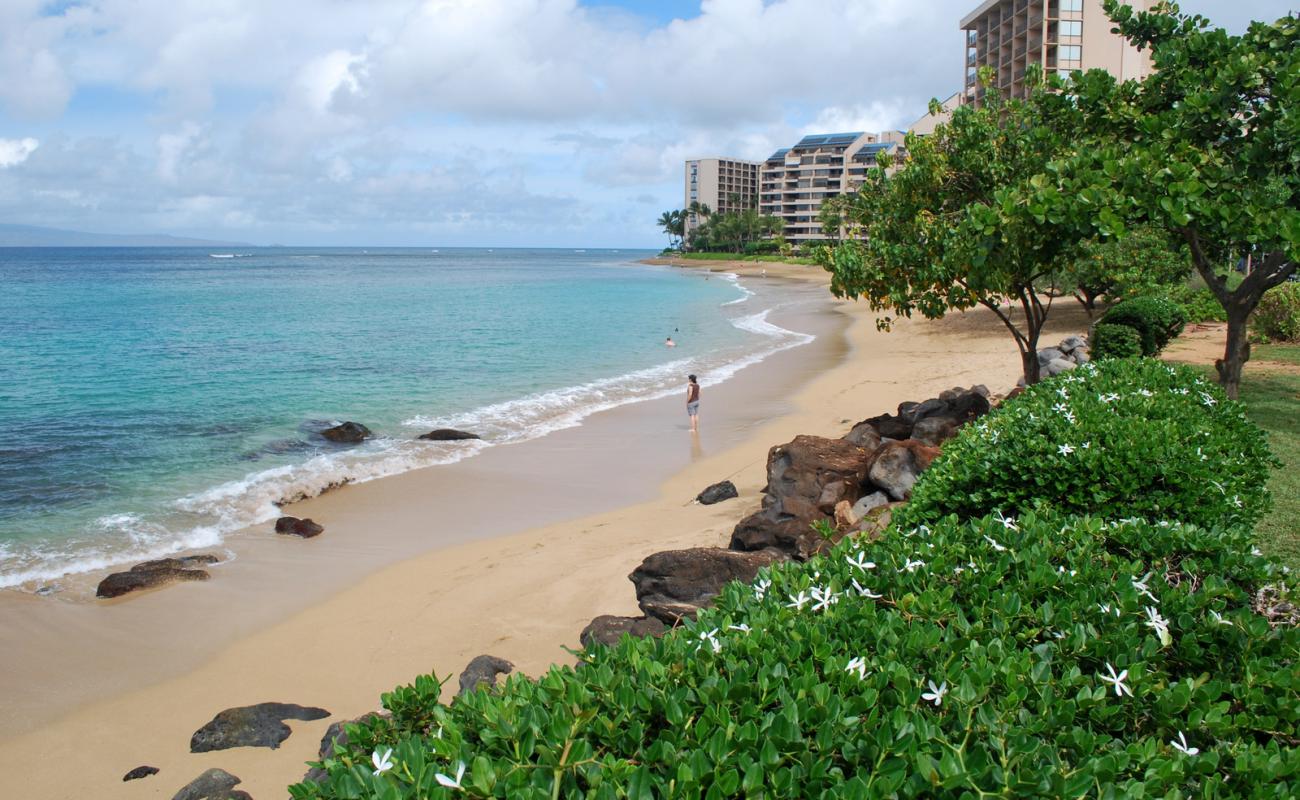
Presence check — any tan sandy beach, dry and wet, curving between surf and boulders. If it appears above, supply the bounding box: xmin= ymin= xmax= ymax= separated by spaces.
xmin=0 ymin=264 xmax=1087 ymax=800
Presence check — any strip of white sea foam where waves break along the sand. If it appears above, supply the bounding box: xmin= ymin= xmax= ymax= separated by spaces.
xmin=0 ymin=290 xmax=815 ymax=588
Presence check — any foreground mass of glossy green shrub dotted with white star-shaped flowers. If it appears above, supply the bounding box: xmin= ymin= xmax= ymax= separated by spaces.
xmin=291 ymin=514 xmax=1300 ymax=800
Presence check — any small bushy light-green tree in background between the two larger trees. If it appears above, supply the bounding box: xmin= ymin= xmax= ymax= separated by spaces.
xmin=1070 ymin=225 xmax=1192 ymax=316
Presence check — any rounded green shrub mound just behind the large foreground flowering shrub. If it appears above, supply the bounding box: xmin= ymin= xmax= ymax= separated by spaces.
xmin=900 ymin=359 xmax=1274 ymax=535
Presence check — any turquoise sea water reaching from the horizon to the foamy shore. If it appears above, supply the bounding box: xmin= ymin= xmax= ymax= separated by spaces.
xmin=0 ymin=248 xmax=807 ymax=588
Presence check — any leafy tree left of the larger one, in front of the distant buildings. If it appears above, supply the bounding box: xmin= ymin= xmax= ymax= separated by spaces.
xmin=818 ymin=70 xmax=1092 ymax=384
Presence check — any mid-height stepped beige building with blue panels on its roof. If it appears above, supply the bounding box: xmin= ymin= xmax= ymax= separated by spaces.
xmin=758 ymin=131 xmax=902 ymax=247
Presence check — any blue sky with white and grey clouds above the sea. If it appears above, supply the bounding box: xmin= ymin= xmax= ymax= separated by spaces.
xmin=0 ymin=0 xmax=1295 ymax=247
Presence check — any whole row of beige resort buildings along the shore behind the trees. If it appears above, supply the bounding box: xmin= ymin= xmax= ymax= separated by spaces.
xmin=685 ymin=0 xmax=1156 ymax=247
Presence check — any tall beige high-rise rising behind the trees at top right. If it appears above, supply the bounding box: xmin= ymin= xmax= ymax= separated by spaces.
xmin=961 ymin=0 xmax=1154 ymax=103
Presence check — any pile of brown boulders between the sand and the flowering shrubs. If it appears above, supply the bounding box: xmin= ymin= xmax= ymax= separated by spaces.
xmin=580 ymin=386 xmax=992 ymax=647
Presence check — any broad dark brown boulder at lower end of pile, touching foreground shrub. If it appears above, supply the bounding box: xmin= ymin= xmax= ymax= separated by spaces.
xmin=628 ymin=548 xmax=787 ymax=626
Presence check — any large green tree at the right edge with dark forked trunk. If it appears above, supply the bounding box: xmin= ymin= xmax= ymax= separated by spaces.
xmin=1050 ymin=0 xmax=1300 ymax=398
